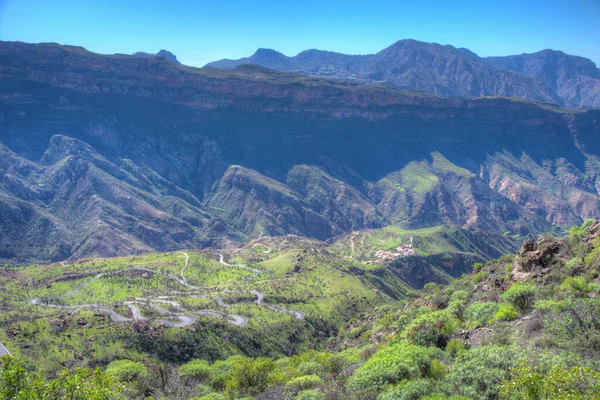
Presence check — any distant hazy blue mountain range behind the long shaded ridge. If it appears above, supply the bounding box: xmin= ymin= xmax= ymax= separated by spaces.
xmin=207 ymin=40 xmax=600 ymax=108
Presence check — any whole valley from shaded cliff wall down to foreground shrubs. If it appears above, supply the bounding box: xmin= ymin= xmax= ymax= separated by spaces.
xmin=0 ymin=37 xmax=600 ymax=400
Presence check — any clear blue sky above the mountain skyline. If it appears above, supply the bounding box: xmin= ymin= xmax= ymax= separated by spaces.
xmin=0 ymin=0 xmax=600 ymax=66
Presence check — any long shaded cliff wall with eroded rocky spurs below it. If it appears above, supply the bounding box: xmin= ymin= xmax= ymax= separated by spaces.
xmin=0 ymin=42 xmax=600 ymax=259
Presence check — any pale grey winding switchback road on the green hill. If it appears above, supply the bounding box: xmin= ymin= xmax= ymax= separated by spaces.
xmin=30 ymin=252 xmax=305 ymax=328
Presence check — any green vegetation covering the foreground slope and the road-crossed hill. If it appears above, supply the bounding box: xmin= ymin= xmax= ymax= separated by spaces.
xmin=0 ymin=222 xmax=600 ymax=400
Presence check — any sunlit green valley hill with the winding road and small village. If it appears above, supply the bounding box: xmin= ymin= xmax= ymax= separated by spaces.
xmin=0 ymin=227 xmax=512 ymax=368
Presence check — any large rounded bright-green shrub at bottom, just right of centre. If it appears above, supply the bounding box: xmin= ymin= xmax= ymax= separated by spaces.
xmin=348 ymin=342 xmax=444 ymax=390
